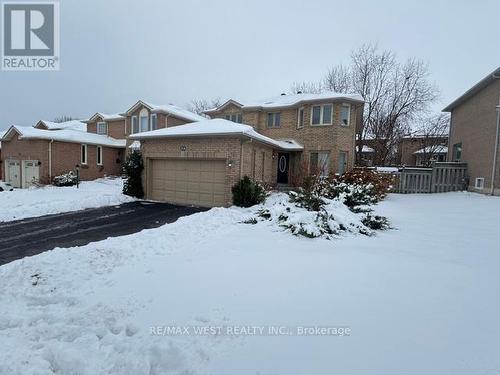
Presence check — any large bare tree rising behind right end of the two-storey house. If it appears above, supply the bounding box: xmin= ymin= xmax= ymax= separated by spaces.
xmin=323 ymin=44 xmax=438 ymax=164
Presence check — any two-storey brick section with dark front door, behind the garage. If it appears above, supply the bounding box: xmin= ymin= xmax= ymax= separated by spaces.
xmin=205 ymin=92 xmax=364 ymax=179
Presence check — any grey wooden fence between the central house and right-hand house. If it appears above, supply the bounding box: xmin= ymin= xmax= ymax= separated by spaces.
xmin=394 ymin=162 xmax=467 ymax=194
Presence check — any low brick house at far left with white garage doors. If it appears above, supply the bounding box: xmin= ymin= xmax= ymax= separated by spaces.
xmin=0 ymin=122 xmax=125 ymax=188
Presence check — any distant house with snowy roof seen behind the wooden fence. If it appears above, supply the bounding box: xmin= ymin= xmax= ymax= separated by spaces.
xmin=396 ymin=132 xmax=448 ymax=166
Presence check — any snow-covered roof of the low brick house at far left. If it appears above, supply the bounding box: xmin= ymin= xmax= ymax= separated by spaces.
xmin=0 ymin=125 xmax=126 ymax=148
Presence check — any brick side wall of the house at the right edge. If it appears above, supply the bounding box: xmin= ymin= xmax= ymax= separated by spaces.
xmin=448 ymin=79 xmax=500 ymax=194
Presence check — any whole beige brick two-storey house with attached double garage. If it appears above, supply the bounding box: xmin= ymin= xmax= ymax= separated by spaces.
xmin=129 ymin=93 xmax=363 ymax=206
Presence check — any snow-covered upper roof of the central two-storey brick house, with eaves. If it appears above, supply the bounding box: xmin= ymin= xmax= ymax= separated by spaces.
xmin=205 ymin=91 xmax=364 ymax=114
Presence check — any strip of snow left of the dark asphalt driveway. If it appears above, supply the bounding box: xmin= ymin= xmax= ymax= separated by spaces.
xmin=0 ymin=178 xmax=134 ymax=222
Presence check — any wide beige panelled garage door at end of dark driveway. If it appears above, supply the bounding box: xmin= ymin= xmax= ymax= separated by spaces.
xmin=148 ymin=159 xmax=226 ymax=207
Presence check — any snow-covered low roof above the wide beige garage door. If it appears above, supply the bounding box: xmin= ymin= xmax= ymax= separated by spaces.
xmin=129 ymin=119 xmax=304 ymax=151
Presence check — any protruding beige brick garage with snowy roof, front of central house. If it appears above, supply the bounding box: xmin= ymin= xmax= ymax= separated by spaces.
xmin=129 ymin=119 xmax=304 ymax=207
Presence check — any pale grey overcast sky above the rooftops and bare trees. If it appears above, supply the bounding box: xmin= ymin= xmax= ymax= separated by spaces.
xmin=0 ymin=0 xmax=500 ymax=129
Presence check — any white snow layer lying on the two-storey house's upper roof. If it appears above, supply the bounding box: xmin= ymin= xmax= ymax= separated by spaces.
xmin=235 ymin=92 xmax=364 ymax=108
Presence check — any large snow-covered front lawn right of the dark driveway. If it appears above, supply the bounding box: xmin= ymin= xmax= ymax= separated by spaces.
xmin=0 ymin=193 xmax=500 ymax=375
